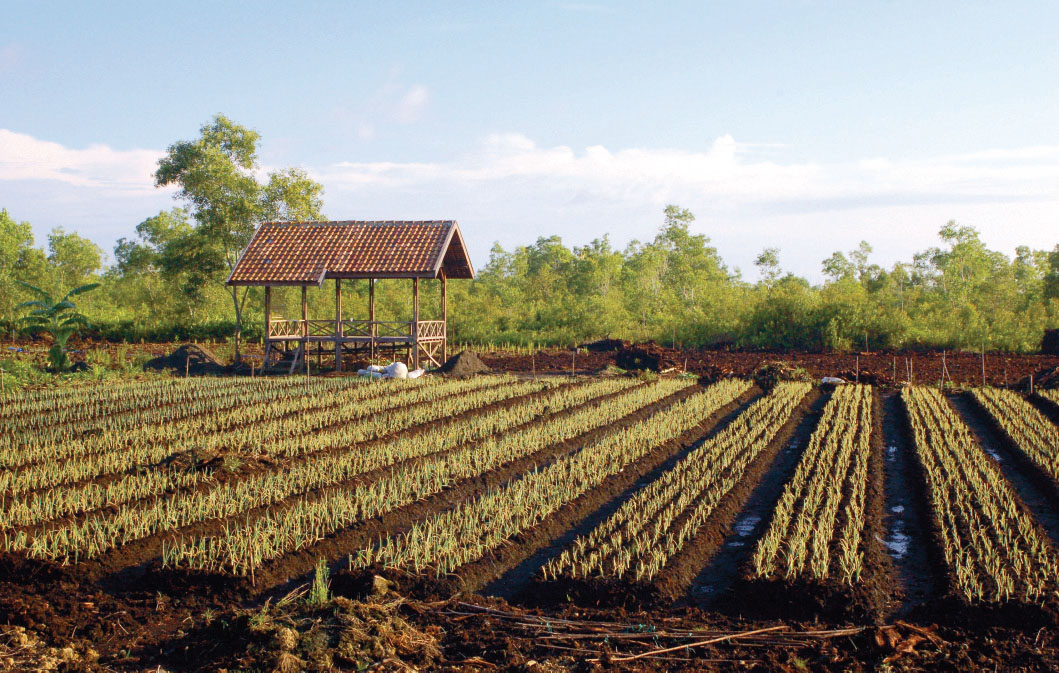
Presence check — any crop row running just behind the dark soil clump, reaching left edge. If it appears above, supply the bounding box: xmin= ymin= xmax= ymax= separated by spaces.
xmin=0 ymin=377 xmax=499 ymax=495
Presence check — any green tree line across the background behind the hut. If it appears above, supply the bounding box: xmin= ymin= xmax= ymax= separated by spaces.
xmin=0 ymin=115 xmax=1059 ymax=351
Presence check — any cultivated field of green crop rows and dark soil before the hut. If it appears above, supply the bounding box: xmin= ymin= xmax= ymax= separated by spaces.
xmin=0 ymin=375 xmax=1059 ymax=670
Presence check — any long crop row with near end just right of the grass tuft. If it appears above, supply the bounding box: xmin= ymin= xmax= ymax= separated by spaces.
xmin=349 ymin=381 xmax=747 ymax=576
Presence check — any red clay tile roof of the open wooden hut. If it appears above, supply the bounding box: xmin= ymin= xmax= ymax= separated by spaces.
xmin=228 ymin=220 xmax=474 ymax=285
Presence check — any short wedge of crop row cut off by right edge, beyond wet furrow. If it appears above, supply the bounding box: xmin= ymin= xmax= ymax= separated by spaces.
xmin=971 ymin=388 xmax=1059 ymax=484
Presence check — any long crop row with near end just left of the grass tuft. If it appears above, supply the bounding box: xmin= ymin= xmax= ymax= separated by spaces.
xmin=164 ymin=381 xmax=688 ymax=576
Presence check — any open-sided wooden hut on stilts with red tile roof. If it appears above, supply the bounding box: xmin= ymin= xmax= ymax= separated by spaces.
xmin=228 ymin=220 xmax=474 ymax=372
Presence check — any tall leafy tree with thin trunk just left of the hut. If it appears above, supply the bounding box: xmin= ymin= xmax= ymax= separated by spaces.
xmin=155 ymin=114 xmax=323 ymax=362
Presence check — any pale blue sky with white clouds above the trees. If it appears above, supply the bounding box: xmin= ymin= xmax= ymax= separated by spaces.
xmin=0 ymin=0 xmax=1059 ymax=278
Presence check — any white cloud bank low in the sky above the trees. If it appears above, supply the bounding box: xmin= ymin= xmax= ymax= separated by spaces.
xmin=0 ymin=128 xmax=1059 ymax=278
